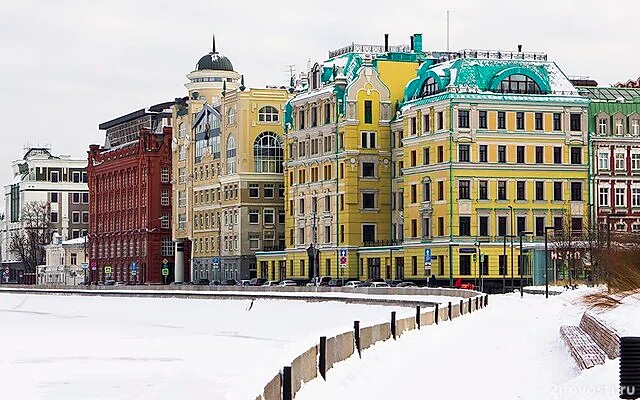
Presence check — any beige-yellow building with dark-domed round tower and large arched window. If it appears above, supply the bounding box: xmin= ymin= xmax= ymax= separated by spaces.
xmin=172 ymin=39 xmax=290 ymax=281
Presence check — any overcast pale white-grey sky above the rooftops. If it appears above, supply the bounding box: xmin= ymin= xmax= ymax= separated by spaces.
xmin=0 ymin=0 xmax=640 ymax=185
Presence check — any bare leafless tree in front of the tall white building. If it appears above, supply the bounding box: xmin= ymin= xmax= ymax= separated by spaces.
xmin=9 ymin=201 xmax=53 ymax=272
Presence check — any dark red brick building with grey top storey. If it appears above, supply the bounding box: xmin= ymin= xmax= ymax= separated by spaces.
xmin=87 ymin=102 xmax=189 ymax=283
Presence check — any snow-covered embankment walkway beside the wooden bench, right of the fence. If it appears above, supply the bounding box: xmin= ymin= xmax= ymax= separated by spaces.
xmin=296 ymin=288 xmax=640 ymax=400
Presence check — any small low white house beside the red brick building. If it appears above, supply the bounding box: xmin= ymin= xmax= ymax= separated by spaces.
xmin=37 ymin=236 xmax=89 ymax=285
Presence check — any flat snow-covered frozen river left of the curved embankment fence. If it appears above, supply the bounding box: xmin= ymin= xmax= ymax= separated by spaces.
xmin=0 ymin=293 xmax=415 ymax=400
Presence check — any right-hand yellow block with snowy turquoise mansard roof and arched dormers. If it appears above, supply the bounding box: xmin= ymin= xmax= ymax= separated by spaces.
xmin=392 ymin=51 xmax=589 ymax=289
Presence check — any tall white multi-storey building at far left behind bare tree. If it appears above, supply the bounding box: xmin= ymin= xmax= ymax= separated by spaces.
xmin=0 ymin=147 xmax=89 ymax=280
